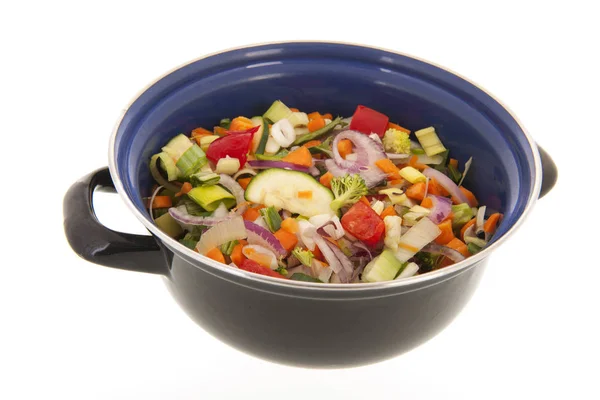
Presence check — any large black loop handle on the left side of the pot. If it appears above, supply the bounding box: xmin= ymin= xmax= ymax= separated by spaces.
xmin=63 ymin=167 xmax=168 ymax=275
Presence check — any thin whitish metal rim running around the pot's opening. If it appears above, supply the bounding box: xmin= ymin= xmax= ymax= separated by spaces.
xmin=108 ymin=40 xmax=542 ymax=291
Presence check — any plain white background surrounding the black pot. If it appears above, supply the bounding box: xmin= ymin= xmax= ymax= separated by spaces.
xmin=0 ymin=1 xmax=600 ymax=400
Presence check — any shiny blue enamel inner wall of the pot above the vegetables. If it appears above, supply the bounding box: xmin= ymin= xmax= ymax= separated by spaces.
xmin=115 ymin=43 xmax=537 ymax=244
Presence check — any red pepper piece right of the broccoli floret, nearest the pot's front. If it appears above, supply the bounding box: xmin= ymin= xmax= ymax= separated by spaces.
xmin=342 ymin=201 xmax=385 ymax=246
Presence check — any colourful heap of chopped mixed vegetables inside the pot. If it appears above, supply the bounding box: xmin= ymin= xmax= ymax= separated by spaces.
xmin=147 ymin=100 xmax=502 ymax=283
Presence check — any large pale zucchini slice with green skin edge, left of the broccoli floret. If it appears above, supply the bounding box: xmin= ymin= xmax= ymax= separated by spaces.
xmin=245 ymin=168 xmax=334 ymax=217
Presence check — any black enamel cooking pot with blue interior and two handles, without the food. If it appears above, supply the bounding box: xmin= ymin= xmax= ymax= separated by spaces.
xmin=64 ymin=42 xmax=557 ymax=368
